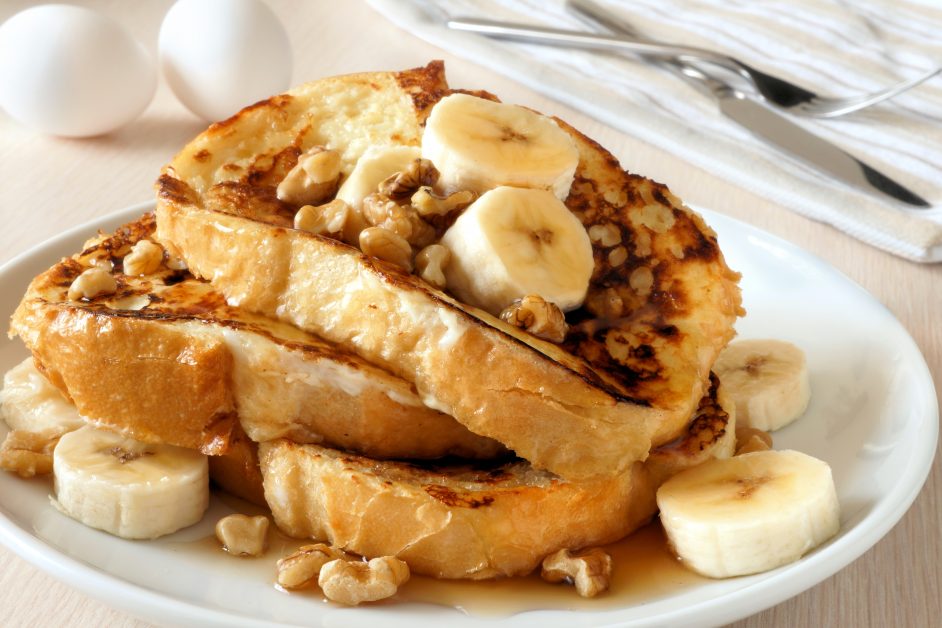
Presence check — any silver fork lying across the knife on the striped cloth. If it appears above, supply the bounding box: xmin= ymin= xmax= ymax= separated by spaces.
xmin=447 ymin=14 xmax=942 ymax=118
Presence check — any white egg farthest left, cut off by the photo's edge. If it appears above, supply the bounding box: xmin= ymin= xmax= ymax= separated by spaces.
xmin=0 ymin=4 xmax=157 ymax=137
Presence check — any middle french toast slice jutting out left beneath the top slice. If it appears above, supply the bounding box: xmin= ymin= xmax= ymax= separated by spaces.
xmin=12 ymin=214 xmax=505 ymax=458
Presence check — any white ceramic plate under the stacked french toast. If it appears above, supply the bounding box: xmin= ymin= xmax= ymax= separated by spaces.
xmin=0 ymin=204 xmax=938 ymax=628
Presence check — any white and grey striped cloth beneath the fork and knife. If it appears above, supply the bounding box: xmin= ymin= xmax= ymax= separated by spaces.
xmin=369 ymin=0 xmax=942 ymax=262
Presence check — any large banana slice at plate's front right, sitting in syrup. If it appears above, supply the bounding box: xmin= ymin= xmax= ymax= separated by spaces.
xmin=657 ymin=451 xmax=840 ymax=578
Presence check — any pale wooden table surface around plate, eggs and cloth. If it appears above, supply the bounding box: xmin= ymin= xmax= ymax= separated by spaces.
xmin=0 ymin=0 xmax=942 ymax=627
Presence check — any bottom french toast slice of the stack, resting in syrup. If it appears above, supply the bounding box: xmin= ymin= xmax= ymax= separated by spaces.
xmin=259 ymin=372 xmax=736 ymax=579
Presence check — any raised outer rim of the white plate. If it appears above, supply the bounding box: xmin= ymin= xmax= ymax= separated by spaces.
xmin=0 ymin=200 xmax=939 ymax=627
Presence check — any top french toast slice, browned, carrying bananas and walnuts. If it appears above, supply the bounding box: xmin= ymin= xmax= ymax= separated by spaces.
xmin=157 ymin=63 xmax=742 ymax=480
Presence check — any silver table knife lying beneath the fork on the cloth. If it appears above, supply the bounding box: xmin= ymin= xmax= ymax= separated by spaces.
xmin=566 ymin=0 xmax=931 ymax=209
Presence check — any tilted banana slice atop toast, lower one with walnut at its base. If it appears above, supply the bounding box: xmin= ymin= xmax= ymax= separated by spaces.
xmin=441 ymin=187 xmax=595 ymax=316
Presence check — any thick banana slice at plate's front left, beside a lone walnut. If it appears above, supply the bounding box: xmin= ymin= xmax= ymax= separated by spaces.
xmin=53 ymin=425 xmax=209 ymax=539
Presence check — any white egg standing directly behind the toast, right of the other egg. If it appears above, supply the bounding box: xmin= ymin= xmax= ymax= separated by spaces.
xmin=159 ymin=0 xmax=292 ymax=121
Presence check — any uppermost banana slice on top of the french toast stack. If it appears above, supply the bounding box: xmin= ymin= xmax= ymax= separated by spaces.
xmin=422 ymin=94 xmax=579 ymax=200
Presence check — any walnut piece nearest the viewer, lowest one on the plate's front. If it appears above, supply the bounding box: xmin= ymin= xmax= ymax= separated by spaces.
xmin=317 ymin=556 xmax=409 ymax=606
